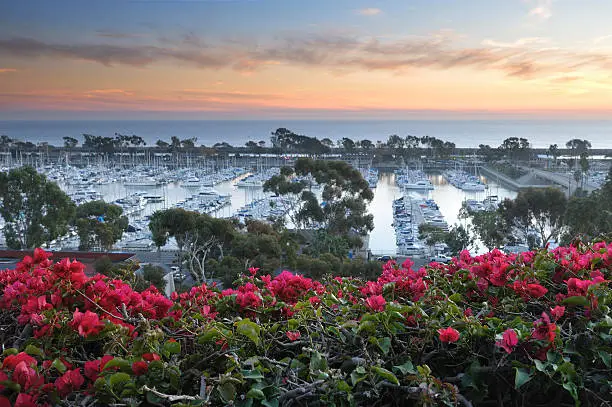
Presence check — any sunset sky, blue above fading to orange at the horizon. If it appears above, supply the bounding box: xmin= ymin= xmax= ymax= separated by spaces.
xmin=0 ymin=0 xmax=612 ymax=119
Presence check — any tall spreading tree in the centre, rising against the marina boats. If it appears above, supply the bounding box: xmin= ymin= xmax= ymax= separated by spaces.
xmin=264 ymin=158 xmax=374 ymax=242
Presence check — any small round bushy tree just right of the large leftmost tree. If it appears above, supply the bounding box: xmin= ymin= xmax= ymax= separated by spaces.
xmin=75 ymin=201 xmax=128 ymax=251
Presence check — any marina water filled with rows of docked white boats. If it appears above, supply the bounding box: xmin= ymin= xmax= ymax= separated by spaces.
xmin=0 ymin=162 xmax=516 ymax=256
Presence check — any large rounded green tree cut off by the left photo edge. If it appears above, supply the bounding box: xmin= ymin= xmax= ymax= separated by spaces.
xmin=0 ymin=167 xmax=75 ymax=249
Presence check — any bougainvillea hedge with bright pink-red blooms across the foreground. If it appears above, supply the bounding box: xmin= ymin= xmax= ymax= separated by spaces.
xmin=0 ymin=242 xmax=612 ymax=407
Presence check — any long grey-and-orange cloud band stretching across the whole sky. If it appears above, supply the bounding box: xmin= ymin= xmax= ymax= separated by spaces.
xmin=0 ymin=32 xmax=612 ymax=79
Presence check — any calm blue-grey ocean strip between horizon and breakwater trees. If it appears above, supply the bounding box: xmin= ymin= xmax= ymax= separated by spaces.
xmin=0 ymin=119 xmax=612 ymax=149
